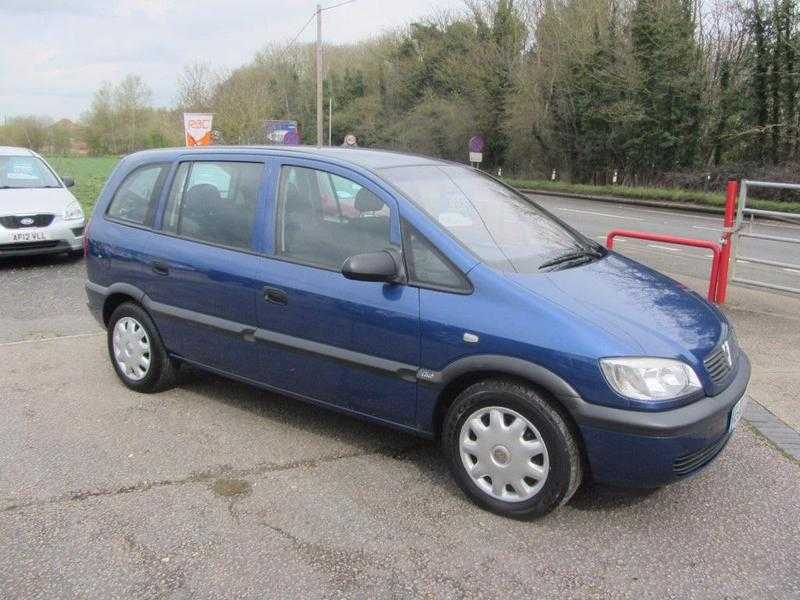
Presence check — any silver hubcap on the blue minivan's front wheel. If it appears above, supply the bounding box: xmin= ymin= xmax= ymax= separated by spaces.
xmin=459 ymin=406 xmax=550 ymax=502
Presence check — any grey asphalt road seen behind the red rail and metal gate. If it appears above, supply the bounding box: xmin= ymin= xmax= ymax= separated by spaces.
xmin=530 ymin=194 xmax=800 ymax=288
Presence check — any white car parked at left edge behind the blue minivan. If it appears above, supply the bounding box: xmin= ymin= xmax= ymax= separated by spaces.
xmin=0 ymin=146 xmax=86 ymax=258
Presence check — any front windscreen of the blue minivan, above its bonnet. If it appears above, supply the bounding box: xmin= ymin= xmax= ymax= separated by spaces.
xmin=381 ymin=165 xmax=588 ymax=273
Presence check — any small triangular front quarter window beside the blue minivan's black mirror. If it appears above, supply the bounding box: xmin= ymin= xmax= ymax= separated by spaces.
xmin=403 ymin=222 xmax=472 ymax=292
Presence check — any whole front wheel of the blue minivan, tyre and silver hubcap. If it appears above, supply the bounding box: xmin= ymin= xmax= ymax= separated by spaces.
xmin=442 ymin=379 xmax=582 ymax=518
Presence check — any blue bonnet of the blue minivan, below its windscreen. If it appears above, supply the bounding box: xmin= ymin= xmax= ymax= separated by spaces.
xmin=508 ymin=253 xmax=726 ymax=361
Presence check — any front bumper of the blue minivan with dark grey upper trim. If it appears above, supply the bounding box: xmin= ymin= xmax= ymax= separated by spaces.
xmin=576 ymin=352 xmax=750 ymax=487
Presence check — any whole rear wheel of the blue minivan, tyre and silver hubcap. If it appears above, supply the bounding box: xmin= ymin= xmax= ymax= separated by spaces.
xmin=108 ymin=302 xmax=177 ymax=393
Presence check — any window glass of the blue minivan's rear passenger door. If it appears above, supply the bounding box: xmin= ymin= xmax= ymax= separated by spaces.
xmin=162 ymin=161 xmax=264 ymax=250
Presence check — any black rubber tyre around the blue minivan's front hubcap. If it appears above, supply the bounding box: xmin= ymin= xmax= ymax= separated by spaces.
xmin=442 ymin=379 xmax=583 ymax=519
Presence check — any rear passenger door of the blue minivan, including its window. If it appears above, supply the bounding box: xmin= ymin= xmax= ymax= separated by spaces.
xmin=146 ymin=155 xmax=266 ymax=378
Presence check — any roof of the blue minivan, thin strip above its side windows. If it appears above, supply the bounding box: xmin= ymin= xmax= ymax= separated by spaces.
xmin=123 ymin=146 xmax=454 ymax=171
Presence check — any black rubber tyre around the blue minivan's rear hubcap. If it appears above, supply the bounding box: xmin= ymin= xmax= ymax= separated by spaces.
xmin=107 ymin=302 xmax=178 ymax=394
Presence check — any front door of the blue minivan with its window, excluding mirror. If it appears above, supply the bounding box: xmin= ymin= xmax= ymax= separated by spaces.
xmin=256 ymin=159 xmax=420 ymax=425
